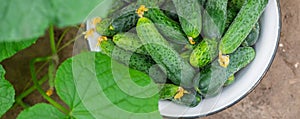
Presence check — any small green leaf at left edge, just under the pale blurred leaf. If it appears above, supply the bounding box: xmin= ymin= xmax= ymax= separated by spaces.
xmin=0 ymin=39 xmax=36 ymax=62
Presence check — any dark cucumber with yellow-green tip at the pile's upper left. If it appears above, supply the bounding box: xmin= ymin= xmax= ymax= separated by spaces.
xmin=96 ymin=4 xmax=139 ymax=37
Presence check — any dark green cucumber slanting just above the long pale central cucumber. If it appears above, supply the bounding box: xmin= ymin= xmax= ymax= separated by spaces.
xmin=144 ymin=8 xmax=189 ymax=44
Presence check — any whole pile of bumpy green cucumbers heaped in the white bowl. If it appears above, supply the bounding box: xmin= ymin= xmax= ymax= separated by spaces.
xmin=96 ymin=0 xmax=268 ymax=107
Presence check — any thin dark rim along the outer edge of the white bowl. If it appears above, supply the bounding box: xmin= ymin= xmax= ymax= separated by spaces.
xmin=164 ymin=0 xmax=282 ymax=119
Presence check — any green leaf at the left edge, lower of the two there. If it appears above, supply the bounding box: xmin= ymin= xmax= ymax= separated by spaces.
xmin=0 ymin=65 xmax=15 ymax=117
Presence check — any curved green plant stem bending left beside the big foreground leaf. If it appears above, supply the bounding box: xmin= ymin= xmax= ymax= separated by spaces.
xmin=30 ymin=57 xmax=69 ymax=114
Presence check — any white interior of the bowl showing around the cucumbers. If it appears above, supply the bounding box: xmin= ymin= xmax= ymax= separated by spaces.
xmin=87 ymin=0 xmax=280 ymax=117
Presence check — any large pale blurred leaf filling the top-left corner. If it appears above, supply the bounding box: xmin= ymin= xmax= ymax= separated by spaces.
xmin=0 ymin=0 xmax=109 ymax=42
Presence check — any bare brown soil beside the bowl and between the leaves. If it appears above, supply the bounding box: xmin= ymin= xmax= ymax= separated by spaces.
xmin=1 ymin=0 xmax=300 ymax=119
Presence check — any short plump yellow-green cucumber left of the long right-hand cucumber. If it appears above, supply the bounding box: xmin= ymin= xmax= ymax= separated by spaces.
xmin=190 ymin=38 xmax=218 ymax=67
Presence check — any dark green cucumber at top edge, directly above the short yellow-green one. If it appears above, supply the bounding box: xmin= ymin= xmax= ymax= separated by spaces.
xmin=203 ymin=0 xmax=228 ymax=38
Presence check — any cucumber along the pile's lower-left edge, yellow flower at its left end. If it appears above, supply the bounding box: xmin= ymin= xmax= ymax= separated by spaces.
xmin=100 ymin=39 xmax=166 ymax=83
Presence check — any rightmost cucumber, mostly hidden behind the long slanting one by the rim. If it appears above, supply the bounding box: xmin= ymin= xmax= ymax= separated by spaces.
xmin=242 ymin=22 xmax=260 ymax=46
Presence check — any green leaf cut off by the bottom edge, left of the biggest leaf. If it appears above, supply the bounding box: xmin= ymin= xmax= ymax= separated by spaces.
xmin=17 ymin=103 xmax=67 ymax=119
